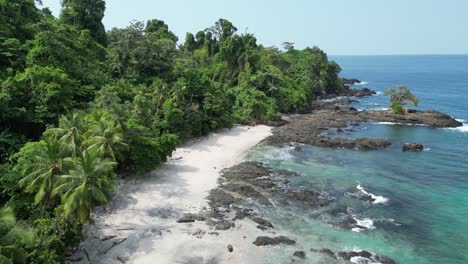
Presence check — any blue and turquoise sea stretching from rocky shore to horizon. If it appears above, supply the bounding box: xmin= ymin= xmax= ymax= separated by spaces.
xmin=248 ymin=55 xmax=468 ymax=264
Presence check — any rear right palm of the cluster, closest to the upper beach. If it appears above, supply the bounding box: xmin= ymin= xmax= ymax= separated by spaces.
xmin=85 ymin=111 xmax=128 ymax=161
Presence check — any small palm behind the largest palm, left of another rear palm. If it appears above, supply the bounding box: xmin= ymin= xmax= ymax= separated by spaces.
xmin=46 ymin=112 xmax=83 ymax=157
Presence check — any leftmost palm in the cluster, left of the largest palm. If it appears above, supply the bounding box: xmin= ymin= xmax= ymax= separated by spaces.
xmin=19 ymin=137 xmax=64 ymax=204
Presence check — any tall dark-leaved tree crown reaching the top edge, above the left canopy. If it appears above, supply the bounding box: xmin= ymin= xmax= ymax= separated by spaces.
xmin=60 ymin=0 xmax=107 ymax=46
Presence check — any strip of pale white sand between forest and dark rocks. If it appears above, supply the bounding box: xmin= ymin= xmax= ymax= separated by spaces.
xmin=72 ymin=126 xmax=271 ymax=264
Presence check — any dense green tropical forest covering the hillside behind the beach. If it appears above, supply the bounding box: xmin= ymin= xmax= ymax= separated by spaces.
xmin=0 ymin=0 xmax=343 ymax=263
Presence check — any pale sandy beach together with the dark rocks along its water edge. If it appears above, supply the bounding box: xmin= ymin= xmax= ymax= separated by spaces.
xmin=70 ymin=90 xmax=464 ymax=263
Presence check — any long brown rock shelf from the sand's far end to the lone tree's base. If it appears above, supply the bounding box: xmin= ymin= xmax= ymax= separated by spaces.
xmin=265 ymin=104 xmax=463 ymax=150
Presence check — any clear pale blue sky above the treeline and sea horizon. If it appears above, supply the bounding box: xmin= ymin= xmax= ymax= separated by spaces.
xmin=43 ymin=0 xmax=468 ymax=55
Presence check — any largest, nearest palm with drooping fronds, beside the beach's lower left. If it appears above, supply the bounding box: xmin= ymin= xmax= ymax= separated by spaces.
xmin=53 ymin=149 xmax=116 ymax=222
